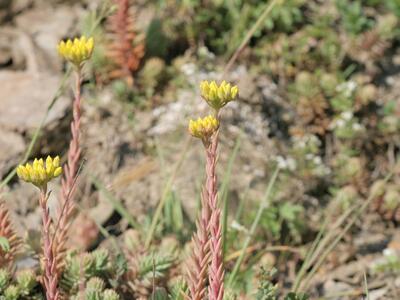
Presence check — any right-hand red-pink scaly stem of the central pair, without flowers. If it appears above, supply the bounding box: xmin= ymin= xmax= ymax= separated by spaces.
xmin=206 ymin=132 xmax=224 ymax=300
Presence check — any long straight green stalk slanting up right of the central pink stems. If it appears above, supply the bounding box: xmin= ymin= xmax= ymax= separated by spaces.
xmin=228 ymin=167 xmax=280 ymax=287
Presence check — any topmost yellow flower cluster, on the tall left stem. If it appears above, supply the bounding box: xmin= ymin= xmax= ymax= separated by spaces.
xmin=57 ymin=36 xmax=94 ymax=67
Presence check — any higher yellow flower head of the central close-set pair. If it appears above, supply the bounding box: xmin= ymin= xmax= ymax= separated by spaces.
xmin=200 ymin=80 xmax=239 ymax=110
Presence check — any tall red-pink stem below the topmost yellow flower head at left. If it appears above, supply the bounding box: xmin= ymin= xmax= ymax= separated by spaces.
xmin=55 ymin=69 xmax=82 ymax=265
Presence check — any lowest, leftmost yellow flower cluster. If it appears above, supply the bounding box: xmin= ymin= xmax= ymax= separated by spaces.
xmin=17 ymin=156 xmax=62 ymax=188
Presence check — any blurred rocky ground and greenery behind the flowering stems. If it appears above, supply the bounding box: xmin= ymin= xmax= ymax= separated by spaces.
xmin=0 ymin=0 xmax=400 ymax=299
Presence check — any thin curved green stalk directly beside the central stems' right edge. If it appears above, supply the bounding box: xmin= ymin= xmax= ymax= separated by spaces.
xmin=221 ymin=133 xmax=242 ymax=258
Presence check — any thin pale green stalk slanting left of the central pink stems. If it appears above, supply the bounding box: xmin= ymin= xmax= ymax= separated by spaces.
xmin=145 ymin=137 xmax=192 ymax=248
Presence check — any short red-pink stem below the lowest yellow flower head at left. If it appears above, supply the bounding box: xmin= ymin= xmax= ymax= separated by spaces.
xmin=39 ymin=187 xmax=59 ymax=300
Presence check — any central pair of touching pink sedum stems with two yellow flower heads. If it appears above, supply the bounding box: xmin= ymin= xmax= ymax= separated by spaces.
xmin=188 ymin=81 xmax=238 ymax=300
